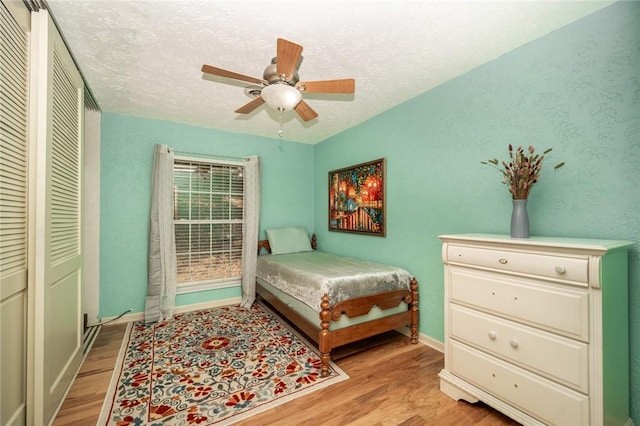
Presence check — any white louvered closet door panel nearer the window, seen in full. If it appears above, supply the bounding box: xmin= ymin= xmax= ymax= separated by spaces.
xmin=29 ymin=10 xmax=84 ymax=424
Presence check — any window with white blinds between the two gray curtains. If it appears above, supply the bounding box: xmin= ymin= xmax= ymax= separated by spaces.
xmin=173 ymin=157 xmax=244 ymax=292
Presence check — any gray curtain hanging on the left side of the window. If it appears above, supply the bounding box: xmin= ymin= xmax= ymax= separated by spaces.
xmin=144 ymin=144 xmax=177 ymax=323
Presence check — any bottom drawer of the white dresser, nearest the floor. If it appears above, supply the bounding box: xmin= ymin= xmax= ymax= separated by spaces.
xmin=450 ymin=341 xmax=589 ymax=425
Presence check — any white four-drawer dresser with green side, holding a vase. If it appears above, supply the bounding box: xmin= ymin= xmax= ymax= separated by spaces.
xmin=440 ymin=234 xmax=633 ymax=426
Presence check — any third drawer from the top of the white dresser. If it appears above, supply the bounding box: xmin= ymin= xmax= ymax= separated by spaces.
xmin=450 ymin=305 xmax=589 ymax=393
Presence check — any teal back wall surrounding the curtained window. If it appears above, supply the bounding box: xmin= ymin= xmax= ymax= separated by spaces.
xmin=100 ymin=113 xmax=314 ymax=318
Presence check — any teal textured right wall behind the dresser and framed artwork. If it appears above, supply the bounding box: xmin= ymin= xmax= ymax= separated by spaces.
xmin=314 ymin=2 xmax=640 ymax=424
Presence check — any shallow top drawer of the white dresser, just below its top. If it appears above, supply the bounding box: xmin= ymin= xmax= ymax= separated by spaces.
xmin=446 ymin=245 xmax=589 ymax=286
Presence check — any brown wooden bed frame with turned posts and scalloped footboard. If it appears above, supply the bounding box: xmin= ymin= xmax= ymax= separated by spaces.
xmin=256 ymin=234 xmax=419 ymax=377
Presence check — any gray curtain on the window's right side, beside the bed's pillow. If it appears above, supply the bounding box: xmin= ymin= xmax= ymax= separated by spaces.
xmin=241 ymin=156 xmax=260 ymax=308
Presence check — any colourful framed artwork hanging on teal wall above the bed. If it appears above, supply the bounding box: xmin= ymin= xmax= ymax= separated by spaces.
xmin=329 ymin=158 xmax=386 ymax=237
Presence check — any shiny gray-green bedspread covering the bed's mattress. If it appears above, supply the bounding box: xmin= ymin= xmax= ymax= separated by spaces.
xmin=257 ymin=251 xmax=411 ymax=312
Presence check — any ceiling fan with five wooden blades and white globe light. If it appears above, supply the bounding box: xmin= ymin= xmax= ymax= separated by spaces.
xmin=202 ymin=38 xmax=355 ymax=121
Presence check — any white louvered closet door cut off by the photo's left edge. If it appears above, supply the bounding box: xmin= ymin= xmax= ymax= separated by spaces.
xmin=0 ymin=2 xmax=30 ymax=426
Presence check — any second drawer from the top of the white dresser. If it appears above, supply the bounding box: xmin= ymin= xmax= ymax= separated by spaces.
xmin=448 ymin=266 xmax=589 ymax=342
